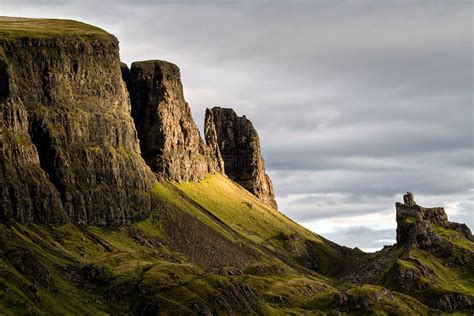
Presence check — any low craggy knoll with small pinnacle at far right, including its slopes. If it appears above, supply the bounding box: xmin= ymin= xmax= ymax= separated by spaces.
xmin=345 ymin=192 xmax=474 ymax=312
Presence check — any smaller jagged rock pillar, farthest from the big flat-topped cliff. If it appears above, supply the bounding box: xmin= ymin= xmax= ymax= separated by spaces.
xmin=204 ymin=107 xmax=277 ymax=208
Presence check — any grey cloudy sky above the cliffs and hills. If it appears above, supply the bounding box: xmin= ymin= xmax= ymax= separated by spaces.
xmin=0 ymin=0 xmax=474 ymax=251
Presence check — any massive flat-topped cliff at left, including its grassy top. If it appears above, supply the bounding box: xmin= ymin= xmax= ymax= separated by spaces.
xmin=0 ymin=18 xmax=155 ymax=225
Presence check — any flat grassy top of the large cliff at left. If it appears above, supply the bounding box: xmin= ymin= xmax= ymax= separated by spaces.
xmin=0 ymin=16 xmax=112 ymax=40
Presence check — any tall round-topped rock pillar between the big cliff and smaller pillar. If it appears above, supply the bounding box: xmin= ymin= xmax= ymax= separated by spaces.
xmin=122 ymin=60 xmax=221 ymax=181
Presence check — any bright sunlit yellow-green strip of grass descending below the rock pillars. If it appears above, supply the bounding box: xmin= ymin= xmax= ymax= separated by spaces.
xmin=176 ymin=175 xmax=361 ymax=274
